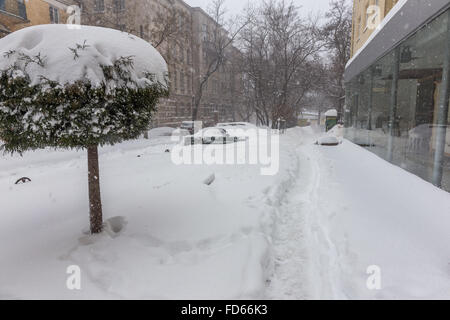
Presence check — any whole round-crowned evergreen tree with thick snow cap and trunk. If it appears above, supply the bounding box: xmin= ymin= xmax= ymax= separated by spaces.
xmin=0 ymin=25 xmax=168 ymax=233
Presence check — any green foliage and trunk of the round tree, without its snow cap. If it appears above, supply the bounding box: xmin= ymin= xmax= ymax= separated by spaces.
xmin=0 ymin=25 xmax=168 ymax=234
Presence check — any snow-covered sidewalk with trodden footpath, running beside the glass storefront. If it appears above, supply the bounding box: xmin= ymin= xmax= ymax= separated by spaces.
xmin=269 ymin=130 xmax=450 ymax=299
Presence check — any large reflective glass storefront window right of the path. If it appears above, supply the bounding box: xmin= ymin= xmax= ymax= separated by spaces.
xmin=345 ymin=10 xmax=450 ymax=191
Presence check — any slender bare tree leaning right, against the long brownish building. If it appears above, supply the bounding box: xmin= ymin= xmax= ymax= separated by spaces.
xmin=192 ymin=0 xmax=248 ymax=121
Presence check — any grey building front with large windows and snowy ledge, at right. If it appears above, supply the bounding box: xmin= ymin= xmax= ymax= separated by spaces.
xmin=345 ymin=0 xmax=450 ymax=191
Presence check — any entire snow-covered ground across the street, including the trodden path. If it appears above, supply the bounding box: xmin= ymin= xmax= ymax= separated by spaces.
xmin=0 ymin=128 xmax=450 ymax=299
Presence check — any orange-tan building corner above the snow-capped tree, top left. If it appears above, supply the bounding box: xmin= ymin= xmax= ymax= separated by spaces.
xmin=0 ymin=0 xmax=72 ymax=37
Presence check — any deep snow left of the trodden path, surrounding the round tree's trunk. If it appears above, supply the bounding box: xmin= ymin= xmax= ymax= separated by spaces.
xmin=0 ymin=134 xmax=277 ymax=299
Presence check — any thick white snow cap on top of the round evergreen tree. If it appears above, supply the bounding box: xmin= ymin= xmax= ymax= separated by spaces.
xmin=0 ymin=24 xmax=168 ymax=87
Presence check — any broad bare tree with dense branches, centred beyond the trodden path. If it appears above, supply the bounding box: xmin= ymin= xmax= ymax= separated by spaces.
xmin=242 ymin=0 xmax=322 ymax=126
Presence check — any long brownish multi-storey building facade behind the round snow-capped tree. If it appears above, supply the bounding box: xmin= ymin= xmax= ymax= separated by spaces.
xmin=76 ymin=0 xmax=242 ymax=127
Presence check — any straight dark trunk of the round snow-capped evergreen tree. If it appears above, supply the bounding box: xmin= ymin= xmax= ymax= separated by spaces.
xmin=88 ymin=146 xmax=103 ymax=234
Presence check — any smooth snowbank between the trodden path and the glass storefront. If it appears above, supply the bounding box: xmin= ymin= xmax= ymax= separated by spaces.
xmin=312 ymin=140 xmax=450 ymax=299
